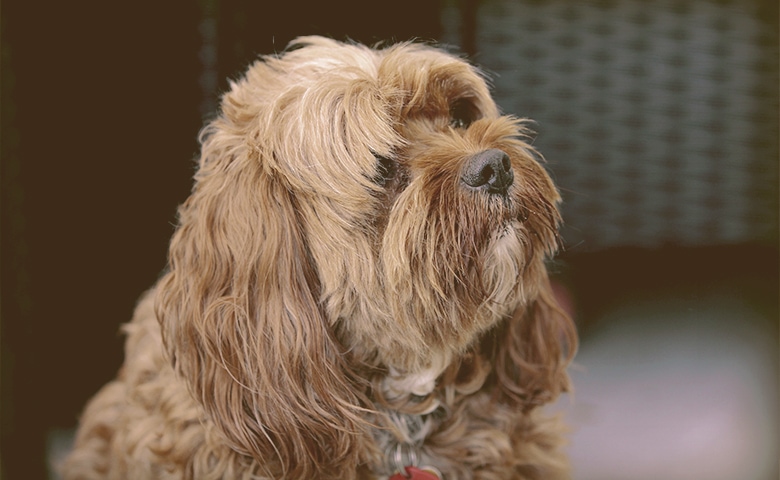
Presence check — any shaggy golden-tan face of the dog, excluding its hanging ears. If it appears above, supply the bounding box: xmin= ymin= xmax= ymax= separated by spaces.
xmin=226 ymin=40 xmax=558 ymax=369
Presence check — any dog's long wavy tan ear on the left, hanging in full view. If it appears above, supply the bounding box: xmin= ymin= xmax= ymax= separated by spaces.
xmin=157 ymin=120 xmax=368 ymax=478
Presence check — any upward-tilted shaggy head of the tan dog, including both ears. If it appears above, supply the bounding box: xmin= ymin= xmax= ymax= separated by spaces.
xmin=158 ymin=37 xmax=572 ymax=477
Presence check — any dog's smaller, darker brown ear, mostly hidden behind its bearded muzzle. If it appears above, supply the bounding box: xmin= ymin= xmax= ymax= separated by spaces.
xmin=490 ymin=273 xmax=577 ymax=411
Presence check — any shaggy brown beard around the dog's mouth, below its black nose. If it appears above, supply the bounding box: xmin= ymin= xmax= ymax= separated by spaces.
xmin=380 ymin=142 xmax=558 ymax=372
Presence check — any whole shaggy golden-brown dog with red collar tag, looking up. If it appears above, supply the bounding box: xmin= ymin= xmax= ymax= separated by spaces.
xmin=62 ymin=37 xmax=577 ymax=480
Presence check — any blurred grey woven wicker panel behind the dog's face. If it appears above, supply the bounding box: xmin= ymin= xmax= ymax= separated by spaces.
xmin=443 ymin=0 xmax=778 ymax=250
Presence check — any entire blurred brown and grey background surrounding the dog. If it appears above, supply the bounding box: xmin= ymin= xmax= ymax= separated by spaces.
xmin=0 ymin=0 xmax=779 ymax=480
